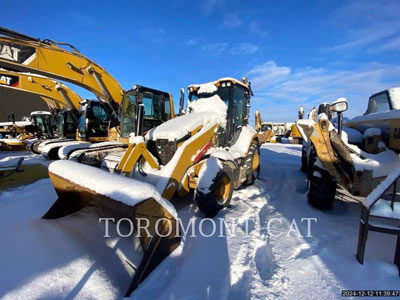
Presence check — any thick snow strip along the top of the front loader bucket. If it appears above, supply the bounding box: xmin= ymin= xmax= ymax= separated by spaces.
xmin=49 ymin=160 xmax=177 ymax=217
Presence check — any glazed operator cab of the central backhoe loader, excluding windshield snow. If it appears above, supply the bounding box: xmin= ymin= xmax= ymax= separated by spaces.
xmin=188 ymin=78 xmax=253 ymax=147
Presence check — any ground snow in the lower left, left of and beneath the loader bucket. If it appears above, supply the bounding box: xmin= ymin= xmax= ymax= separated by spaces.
xmin=0 ymin=179 xmax=136 ymax=300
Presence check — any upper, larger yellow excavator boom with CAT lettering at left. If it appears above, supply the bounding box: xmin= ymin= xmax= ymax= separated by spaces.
xmin=0 ymin=27 xmax=123 ymax=110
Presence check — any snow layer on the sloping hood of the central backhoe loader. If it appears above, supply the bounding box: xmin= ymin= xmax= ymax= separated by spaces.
xmin=146 ymin=112 xmax=217 ymax=141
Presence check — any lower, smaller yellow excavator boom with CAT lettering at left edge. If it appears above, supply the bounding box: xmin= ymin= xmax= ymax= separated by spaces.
xmin=0 ymin=69 xmax=82 ymax=110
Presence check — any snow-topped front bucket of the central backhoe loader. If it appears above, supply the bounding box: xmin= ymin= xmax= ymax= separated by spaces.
xmin=43 ymin=160 xmax=181 ymax=296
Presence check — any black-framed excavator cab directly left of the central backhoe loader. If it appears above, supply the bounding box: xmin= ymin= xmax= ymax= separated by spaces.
xmin=119 ymin=85 xmax=174 ymax=138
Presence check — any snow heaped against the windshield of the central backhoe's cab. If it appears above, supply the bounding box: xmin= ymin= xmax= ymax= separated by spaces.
xmin=186 ymin=95 xmax=228 ymax=128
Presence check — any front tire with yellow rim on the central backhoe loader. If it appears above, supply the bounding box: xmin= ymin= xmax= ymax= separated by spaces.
xmin=194 ymin=164 xmax=234 ymax=218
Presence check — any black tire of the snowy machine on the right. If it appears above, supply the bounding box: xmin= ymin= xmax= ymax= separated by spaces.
xmin=308 ymin=166 xmax=336 ymax=210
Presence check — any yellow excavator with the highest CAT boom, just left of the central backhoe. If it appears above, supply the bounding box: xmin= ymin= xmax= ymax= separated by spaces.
xmin=0 ymin=27 xmax=174 ymax=158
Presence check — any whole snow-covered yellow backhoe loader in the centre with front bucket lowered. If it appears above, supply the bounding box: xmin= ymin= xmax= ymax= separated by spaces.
xmin=44 ymin=78 xmax=260 ymax=295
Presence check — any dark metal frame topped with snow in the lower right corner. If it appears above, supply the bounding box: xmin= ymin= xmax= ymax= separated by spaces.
xmin=357 ymin=167 xmax=400 ymax=276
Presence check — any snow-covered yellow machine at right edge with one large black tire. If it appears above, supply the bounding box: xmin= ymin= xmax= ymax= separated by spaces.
xmin=296 ymin=88 xmax=400 ymax=209
